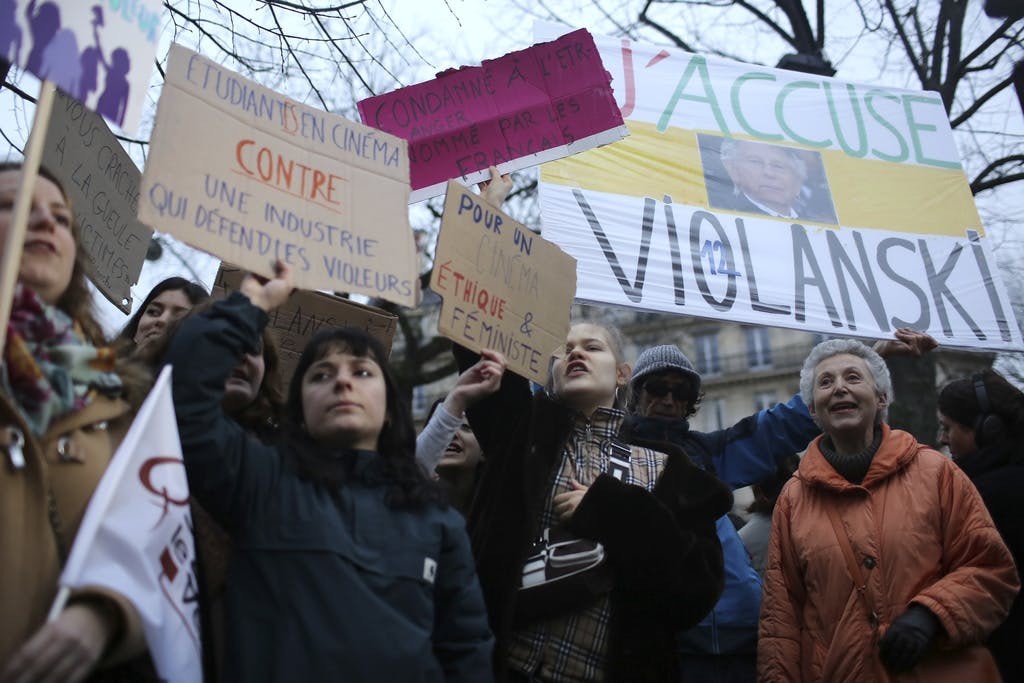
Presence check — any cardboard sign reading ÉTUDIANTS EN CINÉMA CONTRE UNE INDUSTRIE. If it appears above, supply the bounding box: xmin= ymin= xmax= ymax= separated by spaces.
xmin=139 ymin=45 xmax=420 ymax=306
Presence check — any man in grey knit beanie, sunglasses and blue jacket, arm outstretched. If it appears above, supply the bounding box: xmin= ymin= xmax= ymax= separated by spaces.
xmin=628 ymin=328 xmax=936 ymax=683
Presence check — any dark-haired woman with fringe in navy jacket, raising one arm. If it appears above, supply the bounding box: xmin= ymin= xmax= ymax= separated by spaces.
xmin=167 ymin=263 xmax=494 ymax=683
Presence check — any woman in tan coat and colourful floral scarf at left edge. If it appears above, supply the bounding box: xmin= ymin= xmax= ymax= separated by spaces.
xmin=0 ymin=164 xmax=150 ymax=681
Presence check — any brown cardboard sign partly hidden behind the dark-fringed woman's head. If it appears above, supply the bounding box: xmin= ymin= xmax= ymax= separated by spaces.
xmin=213 ymin=263 xmax=398 ymax=385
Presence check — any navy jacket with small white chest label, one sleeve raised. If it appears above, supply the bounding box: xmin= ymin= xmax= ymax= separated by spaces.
xmin=167 ymin=295 xmax=494 ymax=683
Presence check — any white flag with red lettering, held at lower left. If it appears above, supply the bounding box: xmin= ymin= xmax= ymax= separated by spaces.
xmin=60 ymin=367 xmax=203 ymax=683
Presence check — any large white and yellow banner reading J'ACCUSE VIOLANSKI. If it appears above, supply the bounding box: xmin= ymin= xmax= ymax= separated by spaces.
xmin=539 ymin=26 xmax=1022 ymax=349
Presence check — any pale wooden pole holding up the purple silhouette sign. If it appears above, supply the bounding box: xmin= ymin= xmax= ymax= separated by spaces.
xmin=0 ymin=81 xmax=56 ymax=357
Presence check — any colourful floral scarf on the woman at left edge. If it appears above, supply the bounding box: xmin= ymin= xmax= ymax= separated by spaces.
xmin=0 ymin=285 xmax=122 ymax=435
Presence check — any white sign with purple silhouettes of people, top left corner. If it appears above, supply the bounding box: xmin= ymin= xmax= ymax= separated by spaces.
xmin=0 ymin=0 xmax=164 ymax=131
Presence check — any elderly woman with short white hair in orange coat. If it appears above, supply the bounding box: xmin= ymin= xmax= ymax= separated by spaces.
xmin=758 ymin=340 xmax=1020 ymax=683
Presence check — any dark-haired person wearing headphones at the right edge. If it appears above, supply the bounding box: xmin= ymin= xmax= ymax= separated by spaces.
xmin=939 ymin=370 xmax=1024 ymax=681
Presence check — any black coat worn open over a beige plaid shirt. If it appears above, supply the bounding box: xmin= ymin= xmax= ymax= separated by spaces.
xmin=456 ymin=347 xmax=732 ymax=682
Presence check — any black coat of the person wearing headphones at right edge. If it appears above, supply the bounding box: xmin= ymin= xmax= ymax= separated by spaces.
xmin=956 ymin=445 xmax=1024 ymax=683
